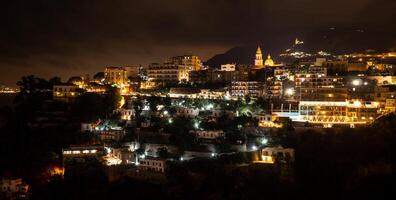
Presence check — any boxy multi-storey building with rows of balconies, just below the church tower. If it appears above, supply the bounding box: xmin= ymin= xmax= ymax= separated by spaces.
xmin=231 ymin=81 xmax=264 ymax=97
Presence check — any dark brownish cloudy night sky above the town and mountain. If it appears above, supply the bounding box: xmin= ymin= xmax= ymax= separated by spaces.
xmin=0 ymin=0 xmax=396 ymax=85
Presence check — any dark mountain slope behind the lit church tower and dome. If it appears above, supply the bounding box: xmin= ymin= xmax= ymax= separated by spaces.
xmin=205 ymin=27 xmax=396 ymax=68
